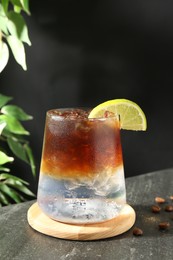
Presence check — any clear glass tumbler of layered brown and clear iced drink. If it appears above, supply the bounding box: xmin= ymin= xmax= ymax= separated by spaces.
xmin=37 ymin=108 xmax=126 ymax=224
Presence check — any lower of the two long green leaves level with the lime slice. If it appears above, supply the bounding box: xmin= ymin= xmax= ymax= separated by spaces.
xmin=0 ymin=115 xmax=29 ymax=135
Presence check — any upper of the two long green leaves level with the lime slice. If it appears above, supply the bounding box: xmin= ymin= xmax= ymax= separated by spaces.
xmin=1 ymin=105 xmax=33 ymax=121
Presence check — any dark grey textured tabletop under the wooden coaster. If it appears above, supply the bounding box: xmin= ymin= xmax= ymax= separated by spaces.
xmin=0 ymin=169 xmax=173 ymax=260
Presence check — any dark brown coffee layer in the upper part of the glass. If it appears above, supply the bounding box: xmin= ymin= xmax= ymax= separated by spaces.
xmin=41 ymin=109 xmax=122 ymax=178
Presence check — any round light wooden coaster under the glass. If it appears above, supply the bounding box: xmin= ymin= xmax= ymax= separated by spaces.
xmin=27 ymin=202 xmax=136 ymax=240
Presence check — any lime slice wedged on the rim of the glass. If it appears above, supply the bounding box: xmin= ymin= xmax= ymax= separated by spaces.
xmin=88 ymin=99 xmax=147 ymax=131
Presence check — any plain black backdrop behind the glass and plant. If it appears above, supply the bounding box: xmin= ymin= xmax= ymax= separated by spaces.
xmin=0 ymin=0 xmax=173 ymax=194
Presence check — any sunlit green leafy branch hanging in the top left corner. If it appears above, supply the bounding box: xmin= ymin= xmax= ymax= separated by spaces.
xmin=0 ymin=0 xmax=31 ymax=72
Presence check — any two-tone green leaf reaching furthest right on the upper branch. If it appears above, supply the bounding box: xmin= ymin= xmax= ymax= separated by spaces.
xmin=7 ymin=11 xmax=31 ymax=46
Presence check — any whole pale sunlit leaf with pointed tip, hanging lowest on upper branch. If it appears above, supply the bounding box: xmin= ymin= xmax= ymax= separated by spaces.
xmin=6 ymin=35 xmax=27 ymax=70
